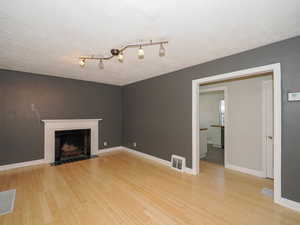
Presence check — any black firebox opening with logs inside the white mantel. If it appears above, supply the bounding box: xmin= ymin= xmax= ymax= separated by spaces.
xmin=54 ymin=129 xmax=91 ymax=165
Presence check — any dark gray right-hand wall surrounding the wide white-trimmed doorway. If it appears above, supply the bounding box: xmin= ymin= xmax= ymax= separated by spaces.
xmin=123 ymin=37 xmax=300 ymax=202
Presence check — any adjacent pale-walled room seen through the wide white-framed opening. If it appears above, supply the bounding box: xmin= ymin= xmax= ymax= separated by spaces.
xmin=199 ymin=73 xmax=274 ymax=179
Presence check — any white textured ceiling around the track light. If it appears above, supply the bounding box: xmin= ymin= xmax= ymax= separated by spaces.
xmin=0 ymin=0 xmax=300 ymax=85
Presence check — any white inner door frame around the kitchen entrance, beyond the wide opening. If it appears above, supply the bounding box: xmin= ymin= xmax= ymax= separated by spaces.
xmin=199 ymin=86 xmax=230 ymax=168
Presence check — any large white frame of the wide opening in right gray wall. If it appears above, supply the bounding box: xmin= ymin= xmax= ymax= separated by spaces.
xmin=192 ymin=63 xmax=282 ymax=204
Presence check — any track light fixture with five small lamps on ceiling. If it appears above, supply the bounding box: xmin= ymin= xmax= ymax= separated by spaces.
xmin=79 ymin=40 xmax=168 ymax=69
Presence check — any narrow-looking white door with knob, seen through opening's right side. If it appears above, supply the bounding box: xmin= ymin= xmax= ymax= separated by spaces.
xmin=263 ymin=80 xmax=274 ymax=179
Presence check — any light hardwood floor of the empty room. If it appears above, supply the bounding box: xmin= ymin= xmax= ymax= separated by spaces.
xmin=0 ymin=152 xmax=300 ymax=225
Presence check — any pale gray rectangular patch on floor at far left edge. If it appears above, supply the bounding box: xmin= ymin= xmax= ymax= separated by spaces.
xmin=0 ymin=189 xmax=16 ymax=216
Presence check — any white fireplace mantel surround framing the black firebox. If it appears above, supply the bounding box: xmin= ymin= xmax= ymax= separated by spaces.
xmin=42 ymin=119 xmax=102 ymax=163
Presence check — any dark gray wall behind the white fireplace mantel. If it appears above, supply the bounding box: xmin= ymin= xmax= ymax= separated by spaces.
xmin=0 ymin=70 xmax=122 ymax=165
